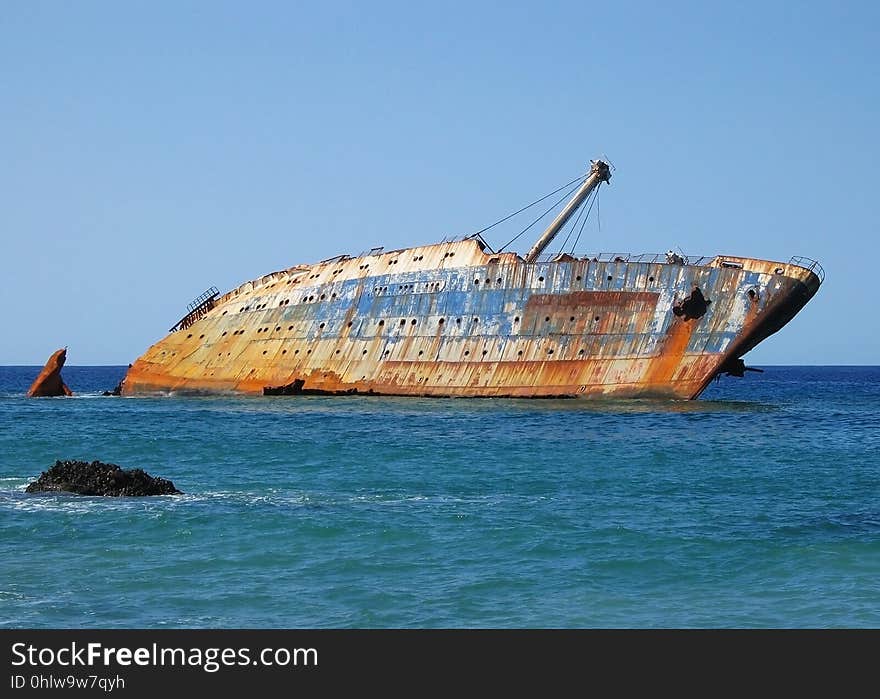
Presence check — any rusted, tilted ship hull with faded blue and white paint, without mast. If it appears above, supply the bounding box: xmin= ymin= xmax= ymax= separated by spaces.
xmin=123 ymin=238 xmax=822 ymax=399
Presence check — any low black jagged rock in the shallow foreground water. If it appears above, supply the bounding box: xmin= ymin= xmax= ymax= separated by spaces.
xmin=26 ymin=461 xmax=182 ymax=496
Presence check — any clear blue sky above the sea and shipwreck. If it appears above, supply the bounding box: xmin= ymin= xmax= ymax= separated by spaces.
xmin=0 ymin=0 xmax=880 ymax=365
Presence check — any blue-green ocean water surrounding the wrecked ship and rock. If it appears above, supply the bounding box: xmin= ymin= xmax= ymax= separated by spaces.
xmin=0 ymin=366 xmax=880 ymax=628
